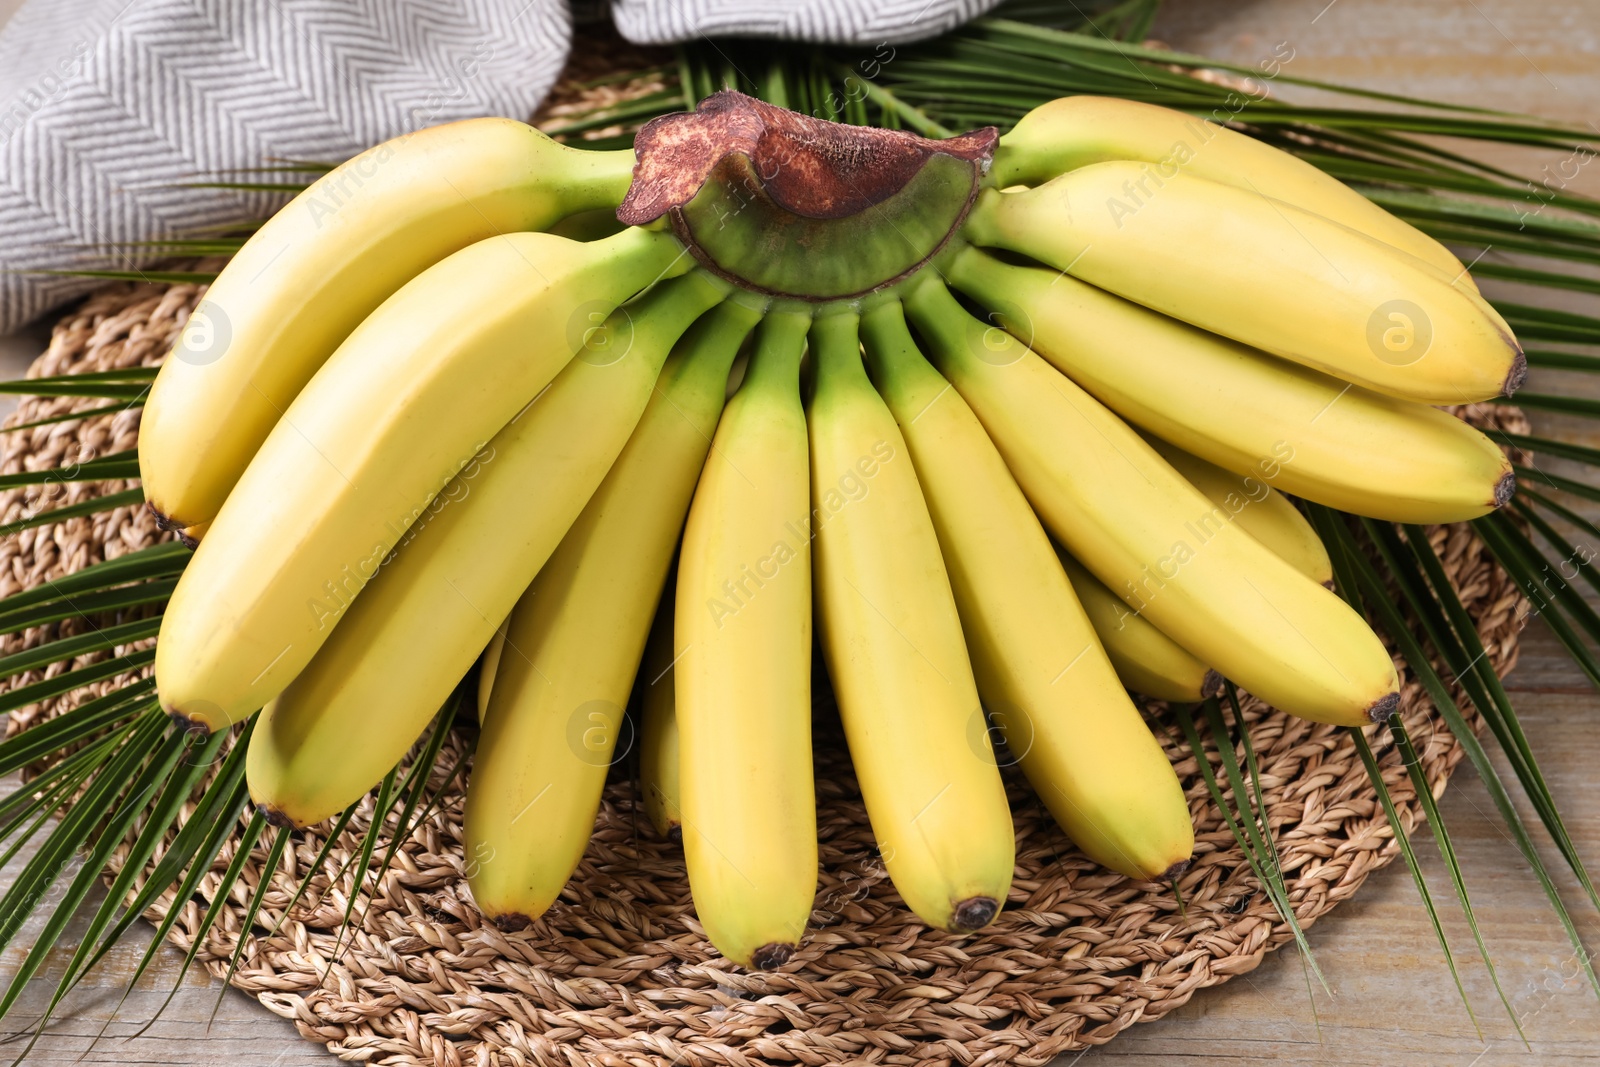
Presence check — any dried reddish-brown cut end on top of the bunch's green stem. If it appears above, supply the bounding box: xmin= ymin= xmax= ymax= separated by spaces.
xmin=616 ymin=90 xmax=998 ymax=226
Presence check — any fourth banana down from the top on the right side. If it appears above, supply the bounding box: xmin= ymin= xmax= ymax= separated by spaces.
xmin=906 ymin=274 xmax=1400 ymax=726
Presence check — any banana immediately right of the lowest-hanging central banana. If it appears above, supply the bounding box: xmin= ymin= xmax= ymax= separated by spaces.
xmin=812 ymin=312 xmax=1014 ymax=931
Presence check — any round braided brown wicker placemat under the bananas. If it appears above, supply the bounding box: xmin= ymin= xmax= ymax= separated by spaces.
xmin=0 ymin=285 xmax=1523 ymax=1067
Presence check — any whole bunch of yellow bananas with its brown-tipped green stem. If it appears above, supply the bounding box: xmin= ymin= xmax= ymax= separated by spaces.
xmin=139 ymin=93 xmax=1525 ymax=968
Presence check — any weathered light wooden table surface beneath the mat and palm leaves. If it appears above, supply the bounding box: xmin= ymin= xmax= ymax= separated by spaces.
xmin=0 ymin=0 xmax=1600 ymax=1067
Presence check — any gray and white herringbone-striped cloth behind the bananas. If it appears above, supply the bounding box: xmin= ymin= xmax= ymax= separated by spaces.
xmin=0 ymin=0 xmax=997 ymax=334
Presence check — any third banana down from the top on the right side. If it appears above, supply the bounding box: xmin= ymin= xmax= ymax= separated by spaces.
xmin=949 ymin=248 xmax=1515 ymax=523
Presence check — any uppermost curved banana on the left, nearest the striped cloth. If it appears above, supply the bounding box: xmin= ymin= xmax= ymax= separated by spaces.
xmin=139 ymin=118 xmax=634 ymax=536
